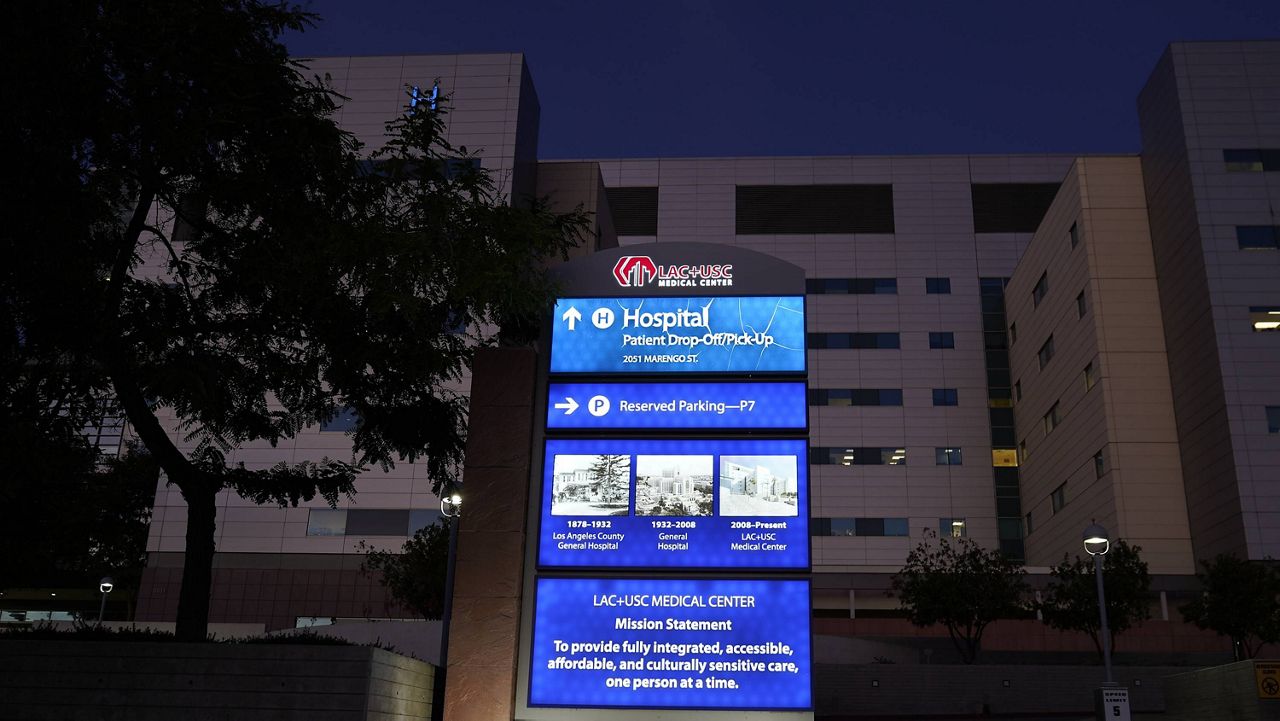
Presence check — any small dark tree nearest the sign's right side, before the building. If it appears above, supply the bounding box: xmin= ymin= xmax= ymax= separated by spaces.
xmin=891 ymin=530 xmax=1029 ymax=663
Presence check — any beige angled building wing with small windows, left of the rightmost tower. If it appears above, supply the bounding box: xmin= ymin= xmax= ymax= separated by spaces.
xmin=1006 ymin=158 xmax=1194 ymax=574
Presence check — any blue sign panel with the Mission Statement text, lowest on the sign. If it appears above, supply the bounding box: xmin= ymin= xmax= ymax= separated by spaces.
xmin=529 ymin=579 xmax=813 ymax=711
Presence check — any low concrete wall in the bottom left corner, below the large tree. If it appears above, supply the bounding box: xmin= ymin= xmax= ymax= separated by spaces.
xmin=0 ymin=640 xmax=434 ymax=721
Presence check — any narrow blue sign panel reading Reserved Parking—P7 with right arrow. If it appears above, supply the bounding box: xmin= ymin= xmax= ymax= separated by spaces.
xmin=547 ymin=382 xmax=808 ymax=429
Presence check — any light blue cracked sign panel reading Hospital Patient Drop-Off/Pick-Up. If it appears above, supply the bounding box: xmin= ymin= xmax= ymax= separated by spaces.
xmin=550 ymin=296 xmax=805 ymax=373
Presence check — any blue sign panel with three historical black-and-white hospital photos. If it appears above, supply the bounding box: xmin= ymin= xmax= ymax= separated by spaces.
xmin=538 ymin=439 xmax=809 ymax=569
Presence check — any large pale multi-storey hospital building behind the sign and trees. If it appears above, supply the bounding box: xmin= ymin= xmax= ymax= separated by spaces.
xmin=129 ymin=42 xmax=1280 ymax=629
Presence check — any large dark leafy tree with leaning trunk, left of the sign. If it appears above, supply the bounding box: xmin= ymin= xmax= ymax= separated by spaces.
xmin=0 ymin=0 xmax=585 ymax=640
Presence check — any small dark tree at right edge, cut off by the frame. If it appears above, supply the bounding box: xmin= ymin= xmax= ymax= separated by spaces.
xmin=1179 ymin=555 xmax=1280 ymax=661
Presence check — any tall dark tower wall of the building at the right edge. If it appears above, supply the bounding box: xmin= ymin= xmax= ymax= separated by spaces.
xmin=1138 ymin=41 xmax=1280 ymax=558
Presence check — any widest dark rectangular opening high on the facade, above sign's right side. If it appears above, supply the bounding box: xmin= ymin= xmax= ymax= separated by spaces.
xmin=737 ymin=184 xmax=893 ymax=236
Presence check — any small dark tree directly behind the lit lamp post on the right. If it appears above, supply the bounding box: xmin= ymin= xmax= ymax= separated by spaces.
xmin=1037 ymin=540 xmax=1151 ymax=658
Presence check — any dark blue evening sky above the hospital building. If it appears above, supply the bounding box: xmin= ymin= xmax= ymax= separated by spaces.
xmin=288 ymin=0 xmax=1280 ymax=159
